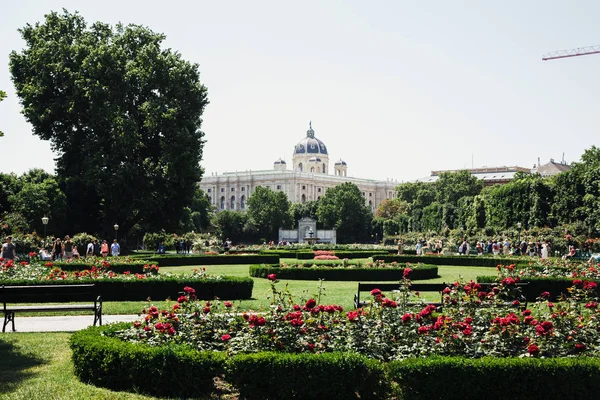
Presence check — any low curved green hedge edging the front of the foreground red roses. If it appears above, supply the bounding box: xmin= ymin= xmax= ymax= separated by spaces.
xmin=70 ymin=323 xmax=600 ymax=400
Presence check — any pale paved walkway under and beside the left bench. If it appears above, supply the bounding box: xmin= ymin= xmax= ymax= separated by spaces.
xmin=2 ymin=313 xmax=142 ymax=333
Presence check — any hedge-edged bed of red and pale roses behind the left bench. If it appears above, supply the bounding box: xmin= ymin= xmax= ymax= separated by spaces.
xmin=0 ymin=260 xmax=254 ymax=302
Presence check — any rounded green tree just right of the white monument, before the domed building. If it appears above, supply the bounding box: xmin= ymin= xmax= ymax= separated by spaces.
xmin=317 ymin=182 xmax=372 ymax=243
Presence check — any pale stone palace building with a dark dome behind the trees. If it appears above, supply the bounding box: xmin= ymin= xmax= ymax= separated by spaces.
xmin=200 ymin=122 xmax=398 ymax=220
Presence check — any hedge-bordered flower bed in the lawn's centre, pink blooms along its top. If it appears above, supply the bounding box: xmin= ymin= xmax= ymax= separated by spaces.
xmin=250 ymin=260 xmax=438 ymax=281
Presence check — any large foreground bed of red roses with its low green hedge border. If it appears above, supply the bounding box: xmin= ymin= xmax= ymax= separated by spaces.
xmin=71 ymin=277 xmax=600 ymax=399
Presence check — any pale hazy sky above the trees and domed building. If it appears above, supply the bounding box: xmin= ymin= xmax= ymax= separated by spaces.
xmin=0 ymin=0 xmax=600 ymax=182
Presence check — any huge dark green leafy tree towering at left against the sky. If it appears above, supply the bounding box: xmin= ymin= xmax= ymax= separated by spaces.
xmin=10 ymin=10 xmax=208 ymax=238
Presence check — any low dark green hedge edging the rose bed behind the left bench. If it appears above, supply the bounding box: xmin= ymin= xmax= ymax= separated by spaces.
xmin=2 ymin=276 xmax=254 ymax=302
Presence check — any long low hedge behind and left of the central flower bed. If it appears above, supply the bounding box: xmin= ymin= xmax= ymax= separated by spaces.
xmin=148 ymin=254 xmax=279 ymax=267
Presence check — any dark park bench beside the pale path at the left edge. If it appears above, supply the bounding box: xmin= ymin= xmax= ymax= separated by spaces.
xmin=0 ymin=284 xmax=102 ymax=332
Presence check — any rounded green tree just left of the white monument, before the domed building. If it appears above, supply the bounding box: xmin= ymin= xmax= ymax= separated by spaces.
xmin=248 ymin=186 xmax=292 ymax=240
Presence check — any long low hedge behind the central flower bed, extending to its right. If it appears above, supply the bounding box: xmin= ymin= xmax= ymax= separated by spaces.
xmin=373 ymin=255 xmax=532 ymax=267
